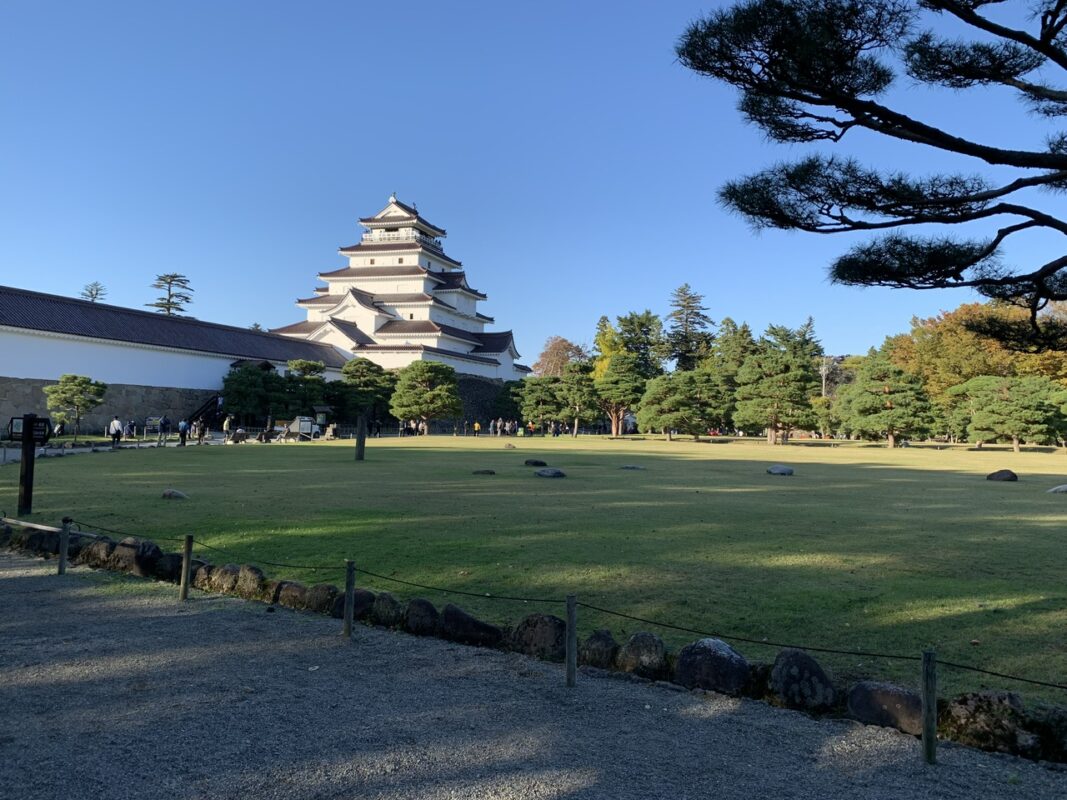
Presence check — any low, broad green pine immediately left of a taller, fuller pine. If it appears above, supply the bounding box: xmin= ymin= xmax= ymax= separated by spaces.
xmin=637 ymin=369 xmax=732 ymax=439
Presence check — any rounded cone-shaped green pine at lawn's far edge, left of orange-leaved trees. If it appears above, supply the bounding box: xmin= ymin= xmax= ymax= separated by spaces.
xmin=835 ymin=351 xmax=931 ymax=447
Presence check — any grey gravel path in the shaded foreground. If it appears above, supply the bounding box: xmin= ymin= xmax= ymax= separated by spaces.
xmin=0 ymin=554 xmax=1067 ymax=800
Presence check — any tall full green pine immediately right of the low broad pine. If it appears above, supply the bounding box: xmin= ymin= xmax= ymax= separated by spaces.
xmin=734 ymin=325 xmax=818 ymax=445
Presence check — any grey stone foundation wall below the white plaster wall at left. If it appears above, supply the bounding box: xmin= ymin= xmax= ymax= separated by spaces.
xmin=0 ymin=378 xmax=217 ymax=434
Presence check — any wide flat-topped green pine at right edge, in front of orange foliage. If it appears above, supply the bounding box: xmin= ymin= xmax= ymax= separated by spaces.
xmin=950 ymin=375 xmax=1065 ymax=452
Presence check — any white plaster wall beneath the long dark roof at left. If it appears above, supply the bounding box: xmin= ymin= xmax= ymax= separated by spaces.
xmin=0 ymin=329 xmax=340 ymax=389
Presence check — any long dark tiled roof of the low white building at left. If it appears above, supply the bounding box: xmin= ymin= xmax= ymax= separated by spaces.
xmin=0 ymin=286 xmax=345 ymax=367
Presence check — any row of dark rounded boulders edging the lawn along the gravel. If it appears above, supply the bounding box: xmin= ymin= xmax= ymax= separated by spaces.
xmin=0 ymin=525 xmax=1067 ymax=763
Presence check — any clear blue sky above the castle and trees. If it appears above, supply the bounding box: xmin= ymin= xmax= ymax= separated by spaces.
xmin=0 ymin=0 xmax=1062 ymax=363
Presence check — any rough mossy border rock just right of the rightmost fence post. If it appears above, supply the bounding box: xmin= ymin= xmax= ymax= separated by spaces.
xmin=938 ymin=691 xmax=1040 ymax=757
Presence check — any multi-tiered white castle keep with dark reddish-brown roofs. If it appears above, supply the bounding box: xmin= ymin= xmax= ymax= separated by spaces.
xmin=272 ymin=196 xmax=530 ymax=381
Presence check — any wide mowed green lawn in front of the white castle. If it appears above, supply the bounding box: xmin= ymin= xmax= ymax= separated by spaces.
xmin=0 ymin=436 xmax=1067 ymax=702
